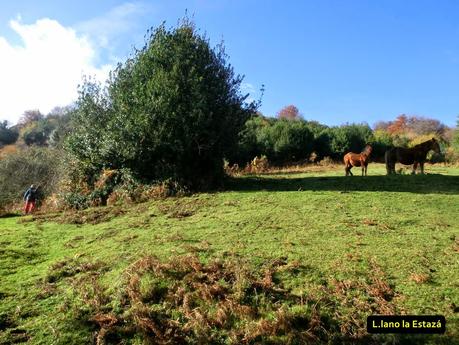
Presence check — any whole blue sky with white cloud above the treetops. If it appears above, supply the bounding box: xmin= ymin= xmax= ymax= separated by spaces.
xmin=0 ymin=0 xmax=459 ymax=126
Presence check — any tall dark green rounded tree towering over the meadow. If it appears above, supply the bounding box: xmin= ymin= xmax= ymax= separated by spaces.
xmin=67 ymin=20 xmax=256 ymax=189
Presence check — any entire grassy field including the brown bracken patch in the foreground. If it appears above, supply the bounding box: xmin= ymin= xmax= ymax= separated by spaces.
xmin=0 ymin=164 xmax=459 ymax=344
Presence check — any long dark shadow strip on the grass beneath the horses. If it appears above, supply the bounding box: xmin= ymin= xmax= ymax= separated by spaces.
xmin=226 ymin=174 xmax=459 ymax=194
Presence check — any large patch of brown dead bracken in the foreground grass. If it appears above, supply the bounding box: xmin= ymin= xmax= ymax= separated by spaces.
xmin=75 ymin=254 xmax=337 ymax=344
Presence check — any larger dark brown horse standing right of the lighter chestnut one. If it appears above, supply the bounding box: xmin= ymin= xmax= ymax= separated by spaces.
xmin=385 ymin=138 xmax=440 ymax=175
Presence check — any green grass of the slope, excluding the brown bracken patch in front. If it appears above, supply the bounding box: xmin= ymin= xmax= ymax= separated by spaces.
xmin=0 ymin=165 xmax=459 ymax=344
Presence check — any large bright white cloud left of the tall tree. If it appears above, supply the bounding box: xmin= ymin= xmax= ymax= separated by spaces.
xmin=0 ymin=18 xmax=112 ymax=123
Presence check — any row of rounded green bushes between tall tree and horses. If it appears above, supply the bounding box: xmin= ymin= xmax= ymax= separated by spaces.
xmin=230 ymin=116 xmax=372 ymax=165
